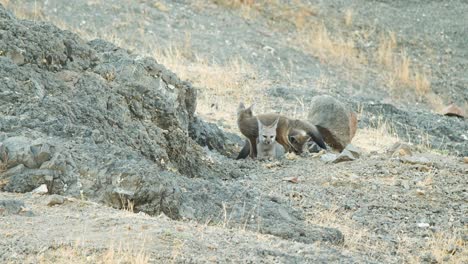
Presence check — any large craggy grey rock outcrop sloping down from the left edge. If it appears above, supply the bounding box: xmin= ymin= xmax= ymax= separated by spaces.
xmin=0 ymin=3 xmax=343 ymax=249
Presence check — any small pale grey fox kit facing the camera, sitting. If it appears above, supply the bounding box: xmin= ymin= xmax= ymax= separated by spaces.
xmin=257 ymin=117 xmax=284 ymax=159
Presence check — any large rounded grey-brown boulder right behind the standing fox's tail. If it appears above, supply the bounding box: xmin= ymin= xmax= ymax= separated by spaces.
xmin=307 ymin=95 xmax=357 ymax=151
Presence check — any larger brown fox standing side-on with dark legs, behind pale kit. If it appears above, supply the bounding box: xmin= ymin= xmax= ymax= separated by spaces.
xmin=237 ymin=103 xmax=326 ymax=159
